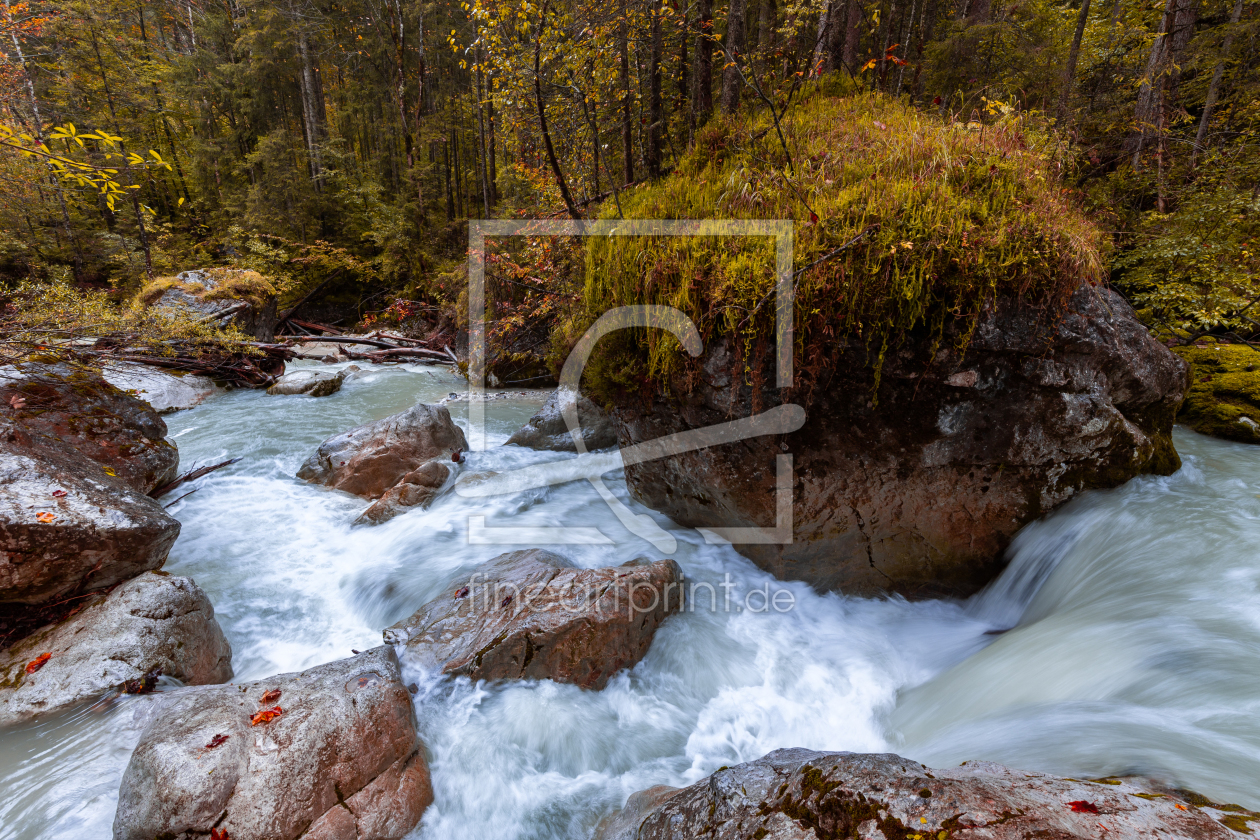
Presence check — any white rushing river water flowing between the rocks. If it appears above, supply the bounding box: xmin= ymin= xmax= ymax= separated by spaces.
xmin=0 ymin=366 xmax=1260 ymax=840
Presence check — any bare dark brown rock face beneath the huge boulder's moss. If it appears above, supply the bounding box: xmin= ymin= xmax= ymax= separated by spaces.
xmin=617 ymin=286 xmax=1186 ymax=597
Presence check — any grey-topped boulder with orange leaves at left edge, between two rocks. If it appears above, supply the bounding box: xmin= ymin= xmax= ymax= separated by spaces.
xmin=0 ymin=422 xmax=179 ymax=604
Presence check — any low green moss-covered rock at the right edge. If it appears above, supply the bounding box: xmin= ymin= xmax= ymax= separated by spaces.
xmin=1173 ymin=344 xmax=1260 ymax=443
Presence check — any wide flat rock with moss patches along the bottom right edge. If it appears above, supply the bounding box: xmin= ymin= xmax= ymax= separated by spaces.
xmin=596 ymin=749 xmax=1260 ymax=840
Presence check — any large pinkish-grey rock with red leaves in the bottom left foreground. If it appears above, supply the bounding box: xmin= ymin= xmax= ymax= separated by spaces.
xmin=113 ymin=647 xmax=433 ymax=840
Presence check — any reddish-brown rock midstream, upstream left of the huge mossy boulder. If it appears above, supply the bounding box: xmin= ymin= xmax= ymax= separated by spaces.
xmin=297 ymin=403 xmax=469 ymax=499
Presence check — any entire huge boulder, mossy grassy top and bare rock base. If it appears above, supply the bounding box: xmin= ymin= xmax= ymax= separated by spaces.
xmin=579 ymin=94 xmax=1186 ymax=597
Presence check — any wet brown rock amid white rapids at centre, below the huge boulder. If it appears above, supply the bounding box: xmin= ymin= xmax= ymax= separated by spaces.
xmin=384 ymin=549 xmax=683 ymax=689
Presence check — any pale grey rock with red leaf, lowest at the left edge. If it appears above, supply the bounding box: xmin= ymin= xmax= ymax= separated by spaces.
xmin=0 ymin=572 xmax=232 ymax=725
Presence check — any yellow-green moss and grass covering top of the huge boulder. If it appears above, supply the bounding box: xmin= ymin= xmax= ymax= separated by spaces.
xmin=567 ymin=92 xmax=1108 ymax=395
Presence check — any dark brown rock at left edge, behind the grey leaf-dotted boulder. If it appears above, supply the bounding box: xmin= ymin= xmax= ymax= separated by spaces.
xmin=0 ymin=364 xmax=179 ymax=494
